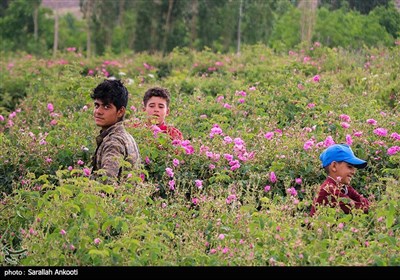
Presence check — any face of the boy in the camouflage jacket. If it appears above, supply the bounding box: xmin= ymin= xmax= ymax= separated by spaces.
xmin=93 ymin=99 xmax=125 ymax=130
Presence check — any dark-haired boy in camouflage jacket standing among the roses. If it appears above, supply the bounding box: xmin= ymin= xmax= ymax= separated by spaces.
xmin=90 ymin=80 xmax=141 ymax=183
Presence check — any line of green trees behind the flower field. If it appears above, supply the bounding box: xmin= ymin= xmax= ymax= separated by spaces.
xmin=0 ymin=0 xmax=400 ymax=57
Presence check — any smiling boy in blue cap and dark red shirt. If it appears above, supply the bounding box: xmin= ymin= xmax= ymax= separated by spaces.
xmin=310 ymin=144 xmax=369 ymax=216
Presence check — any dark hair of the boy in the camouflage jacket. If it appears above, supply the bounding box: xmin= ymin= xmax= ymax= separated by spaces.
xmin=90 ymin=79 xmax=129 ymax=110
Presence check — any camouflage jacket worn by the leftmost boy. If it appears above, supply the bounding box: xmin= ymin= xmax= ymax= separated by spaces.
xmin=91 ymin=121 xmax=141 ymax=183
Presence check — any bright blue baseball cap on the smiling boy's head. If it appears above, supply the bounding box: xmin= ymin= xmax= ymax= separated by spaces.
xmin=319 ymin=144 xmax=367 ymax=168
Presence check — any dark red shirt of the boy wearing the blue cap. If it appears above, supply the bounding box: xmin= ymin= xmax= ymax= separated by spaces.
xmin=310 ymin=177 xmax=369 ymax=216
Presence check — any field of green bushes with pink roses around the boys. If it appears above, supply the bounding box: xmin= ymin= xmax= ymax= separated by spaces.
xmin=0 ymin=42 xmax=400 ymax=266
